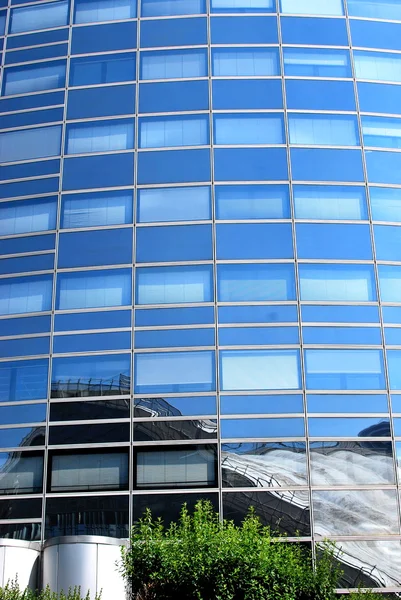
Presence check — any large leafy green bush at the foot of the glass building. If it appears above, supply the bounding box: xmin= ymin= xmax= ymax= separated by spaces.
xmin=120 ymin=501 xmax=386 ymax=600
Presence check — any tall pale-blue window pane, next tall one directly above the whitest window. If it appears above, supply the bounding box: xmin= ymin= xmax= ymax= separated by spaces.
xmin=217 ymin=264 xmax=295 ymax=302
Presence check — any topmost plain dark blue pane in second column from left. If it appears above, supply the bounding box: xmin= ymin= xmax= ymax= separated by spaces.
xmin=71 ymin=21 xmax=137 ymax=54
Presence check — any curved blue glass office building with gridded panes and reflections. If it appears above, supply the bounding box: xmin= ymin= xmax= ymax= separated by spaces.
xmin=0 ymin=0 xmax=401 ymax=591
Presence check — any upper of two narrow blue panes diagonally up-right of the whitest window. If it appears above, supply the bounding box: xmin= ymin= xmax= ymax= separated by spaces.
xmin=301 ymin=304 xmax=380 ymax=323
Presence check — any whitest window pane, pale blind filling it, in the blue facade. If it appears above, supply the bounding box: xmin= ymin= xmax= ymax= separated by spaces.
xmin=220 ymin=350 xmax=300 ymax=391
